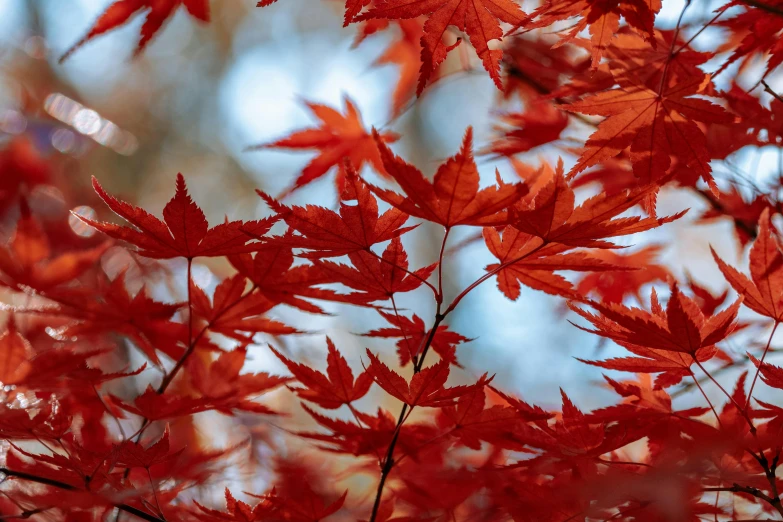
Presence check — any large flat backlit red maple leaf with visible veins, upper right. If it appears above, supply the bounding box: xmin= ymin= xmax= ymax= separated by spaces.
xmin=561 ymin=70 xmax=734 ymax=191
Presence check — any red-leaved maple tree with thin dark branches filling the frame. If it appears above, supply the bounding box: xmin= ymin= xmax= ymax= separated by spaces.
xmin=0 ymin=0 xmax=783 ymax=522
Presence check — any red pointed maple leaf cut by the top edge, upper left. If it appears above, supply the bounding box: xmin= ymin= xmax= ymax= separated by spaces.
xmin=60 ymin=0 xmax=209 ymax=63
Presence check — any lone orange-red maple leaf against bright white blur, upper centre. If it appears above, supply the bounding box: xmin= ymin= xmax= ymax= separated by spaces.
xmin=249 ymin=97 xmax=399 ymax=199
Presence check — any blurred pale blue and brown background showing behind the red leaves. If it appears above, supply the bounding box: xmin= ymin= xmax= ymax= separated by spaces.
xmin=0 ymin=0 xmax=779 ymax=409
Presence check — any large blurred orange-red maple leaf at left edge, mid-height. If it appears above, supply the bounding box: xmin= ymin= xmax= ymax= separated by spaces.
xmin=0 ymin=199 xmax=110 ymax=291
